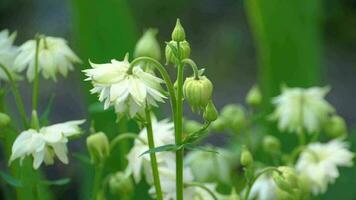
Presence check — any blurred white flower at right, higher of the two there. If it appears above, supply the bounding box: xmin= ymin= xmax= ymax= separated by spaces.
xmin=271 ymin=87 xmax=334 ymax=133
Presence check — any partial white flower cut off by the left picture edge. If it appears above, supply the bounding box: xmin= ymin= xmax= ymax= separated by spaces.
xmin=0 ymin=30 xmax=20 ymax=81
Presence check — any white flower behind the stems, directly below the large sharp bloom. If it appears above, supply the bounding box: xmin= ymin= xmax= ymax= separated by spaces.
xmin=127 ymin=119 xmax=175 ymax=183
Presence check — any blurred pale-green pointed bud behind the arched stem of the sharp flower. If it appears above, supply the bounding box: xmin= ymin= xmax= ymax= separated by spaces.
xmin=134 ymin=28 xmax=161 ymax=60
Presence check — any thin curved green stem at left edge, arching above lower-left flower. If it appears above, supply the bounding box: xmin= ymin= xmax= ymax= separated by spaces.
xmin=0 ymin=64 xmax=28 ymax=128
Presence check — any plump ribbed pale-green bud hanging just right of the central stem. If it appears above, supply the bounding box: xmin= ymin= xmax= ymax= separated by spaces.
xmin=183 ymin=76 xmax=213 ymax=112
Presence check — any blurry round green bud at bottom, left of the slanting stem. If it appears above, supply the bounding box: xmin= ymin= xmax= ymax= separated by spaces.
xmin=109 ymin=172 xmax=134 ymax=199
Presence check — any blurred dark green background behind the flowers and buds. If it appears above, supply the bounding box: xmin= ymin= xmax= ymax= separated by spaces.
xmin=0 ymin=0 xmax=356 ymax=200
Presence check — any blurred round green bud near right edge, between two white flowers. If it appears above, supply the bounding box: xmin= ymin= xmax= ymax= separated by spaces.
xmin=324 ymin=115 xmax=347 ymax=138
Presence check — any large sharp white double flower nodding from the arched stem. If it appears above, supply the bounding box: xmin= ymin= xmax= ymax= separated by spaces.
xmin=83 ymin=55 xmax=166 ymax=117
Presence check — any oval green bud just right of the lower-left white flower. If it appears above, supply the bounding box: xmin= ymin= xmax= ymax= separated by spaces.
xmin=87 ymin=132 xmax=110 ymax=164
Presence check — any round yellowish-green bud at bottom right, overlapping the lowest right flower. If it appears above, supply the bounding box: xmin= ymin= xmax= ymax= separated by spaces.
xmin=272 ymin=166 xmax=298 ymax=193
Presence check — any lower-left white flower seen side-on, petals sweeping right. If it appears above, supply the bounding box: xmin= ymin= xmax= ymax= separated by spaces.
xmin=9 ymin=120 xmax=85 ymax=169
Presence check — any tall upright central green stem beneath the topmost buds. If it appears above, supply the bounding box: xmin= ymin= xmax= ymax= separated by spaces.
xmin=174 ymin=42 xmax=184 ymax=200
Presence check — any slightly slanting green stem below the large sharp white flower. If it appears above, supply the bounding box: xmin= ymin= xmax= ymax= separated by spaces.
xmin=145 ymin=107 xmax=163 ymax=200
